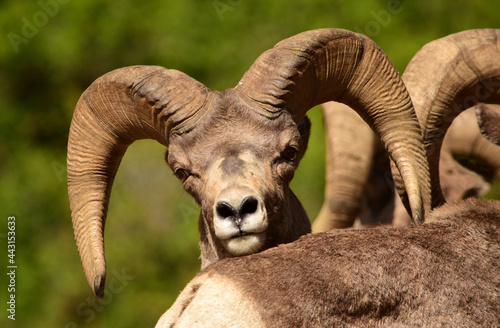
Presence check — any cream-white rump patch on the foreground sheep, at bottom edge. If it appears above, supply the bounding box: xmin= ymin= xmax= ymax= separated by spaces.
xmin=155 ymin=274 xmax=266 ymax=328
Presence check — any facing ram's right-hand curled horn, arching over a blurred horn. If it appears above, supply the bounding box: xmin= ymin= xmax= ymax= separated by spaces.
xmin=237 ymin=29 xmax=430 ymax=222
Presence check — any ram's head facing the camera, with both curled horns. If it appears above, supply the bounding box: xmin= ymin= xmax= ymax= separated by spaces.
xmin=68 ymin=29 xmax=430 ymax=297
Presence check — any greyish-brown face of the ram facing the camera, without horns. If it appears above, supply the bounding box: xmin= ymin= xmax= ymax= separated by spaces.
xmin=167 ymin=93 xmax=309 ymax=256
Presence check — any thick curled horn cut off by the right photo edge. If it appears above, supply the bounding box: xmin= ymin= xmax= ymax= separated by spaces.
xmin=403 ymin=29 xmax=500 ymax=207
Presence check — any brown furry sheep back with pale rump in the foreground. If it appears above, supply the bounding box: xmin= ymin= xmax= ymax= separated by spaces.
xmin=156 ymin=199 xmax=500 ymax=327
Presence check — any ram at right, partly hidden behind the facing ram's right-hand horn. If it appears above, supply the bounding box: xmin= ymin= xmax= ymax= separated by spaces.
xmin=313 ymin=29 xmax=500 ymax=232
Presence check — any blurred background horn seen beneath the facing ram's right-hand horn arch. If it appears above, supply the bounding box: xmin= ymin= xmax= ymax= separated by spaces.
xmin=312 ymin=102 xmax=381 ymax=232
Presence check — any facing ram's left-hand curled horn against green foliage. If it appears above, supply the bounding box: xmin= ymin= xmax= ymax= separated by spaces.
xmin=68 ymin=66 xmax=209 ymax=297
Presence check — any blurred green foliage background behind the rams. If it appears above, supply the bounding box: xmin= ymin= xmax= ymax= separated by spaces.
xmin=0 ymin=0 xmax=500 ymax=328
